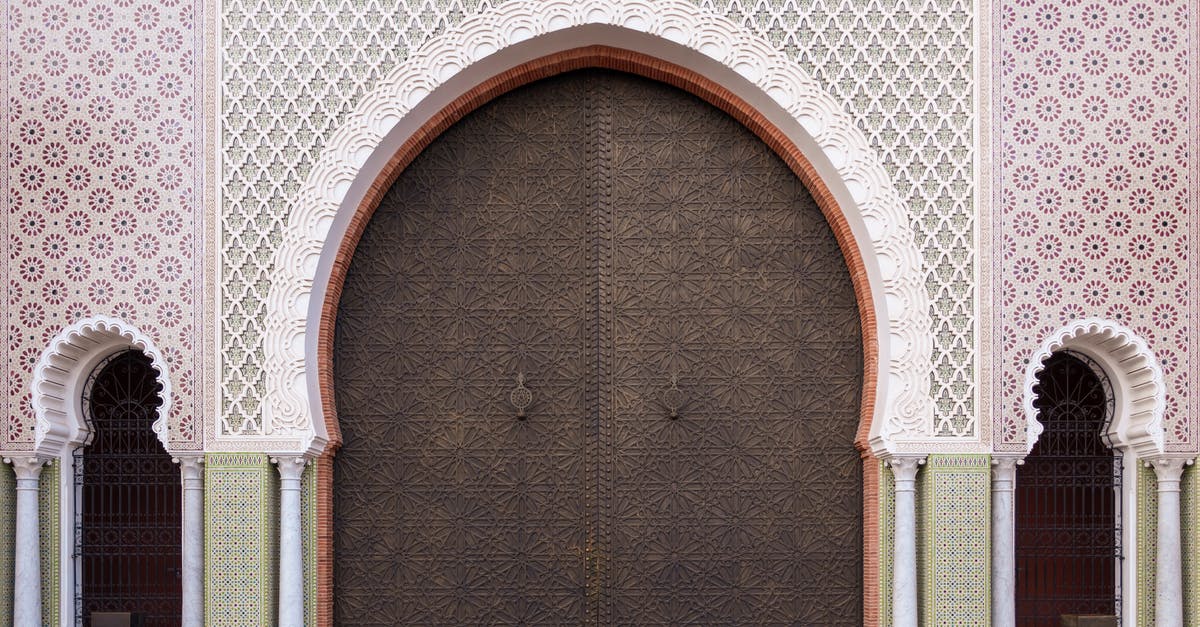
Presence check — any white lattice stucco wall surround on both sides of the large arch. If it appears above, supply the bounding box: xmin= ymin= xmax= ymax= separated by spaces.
xmin=217 ymin=0 xmax=977 ymax=436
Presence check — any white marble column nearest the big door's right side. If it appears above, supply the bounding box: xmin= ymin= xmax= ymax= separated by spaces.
xmin=888 ymin=456 xmax=925 ymax=627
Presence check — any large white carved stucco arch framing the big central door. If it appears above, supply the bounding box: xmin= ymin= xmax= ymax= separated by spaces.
xmin=262 ymin=0 xmax=934 ymax=455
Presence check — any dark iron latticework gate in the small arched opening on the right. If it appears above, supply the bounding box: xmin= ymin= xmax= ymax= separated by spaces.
xmin=1016 ymin=352 xmax=1122 ymax=627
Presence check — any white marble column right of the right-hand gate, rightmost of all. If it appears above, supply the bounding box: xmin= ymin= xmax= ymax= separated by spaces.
xmin=1151 ymin=458 xmax=1192 ymax=627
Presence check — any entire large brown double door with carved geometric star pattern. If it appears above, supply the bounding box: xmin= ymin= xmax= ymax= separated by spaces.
xmin=334 ymin=71 xmax=862 ymax=625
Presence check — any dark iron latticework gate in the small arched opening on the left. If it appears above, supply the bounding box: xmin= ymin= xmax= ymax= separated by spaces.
xmin=74 ymin=351 xmax=182 ymax=627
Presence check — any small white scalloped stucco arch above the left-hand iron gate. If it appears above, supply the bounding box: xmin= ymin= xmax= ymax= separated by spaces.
xmin=32 ymin=316 xmax=172 ymax=458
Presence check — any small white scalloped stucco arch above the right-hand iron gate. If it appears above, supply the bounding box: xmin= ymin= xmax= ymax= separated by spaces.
xmin=1024 ymin=318 xmax=1166 ymax=458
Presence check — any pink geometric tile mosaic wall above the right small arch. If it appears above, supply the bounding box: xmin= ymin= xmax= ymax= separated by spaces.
xmin=994 ymin=0 xmax=1198 ymax=450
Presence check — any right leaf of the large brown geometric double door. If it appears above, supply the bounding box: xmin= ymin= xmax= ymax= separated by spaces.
xmin=600 ymin=73 xmax=863 ymax=626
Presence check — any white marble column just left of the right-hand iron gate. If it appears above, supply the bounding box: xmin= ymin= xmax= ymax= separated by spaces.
xmin=991 ymin=456 xmax=1024 ymax=627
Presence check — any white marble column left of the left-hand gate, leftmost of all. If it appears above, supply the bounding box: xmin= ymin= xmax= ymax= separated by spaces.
xmin=5 ymin=455 xmax=46 ymax=627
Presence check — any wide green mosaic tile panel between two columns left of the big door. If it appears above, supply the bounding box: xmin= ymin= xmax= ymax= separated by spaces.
xmin=204 ymin=453 xmax=278 ymax=627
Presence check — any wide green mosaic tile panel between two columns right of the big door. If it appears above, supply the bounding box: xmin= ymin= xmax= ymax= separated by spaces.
xmin=917 ymin=455 xmax=991 ymax=626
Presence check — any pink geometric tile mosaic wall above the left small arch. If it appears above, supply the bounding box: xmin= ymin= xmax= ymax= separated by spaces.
xmin=0 ymin=0 xmax=204 ymax=448
